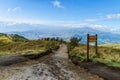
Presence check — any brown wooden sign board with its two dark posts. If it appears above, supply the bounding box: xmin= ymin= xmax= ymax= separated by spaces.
xmin=87 ymin=34 xmax=98 ymax=61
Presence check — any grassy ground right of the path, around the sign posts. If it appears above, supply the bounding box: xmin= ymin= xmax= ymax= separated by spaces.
xmin=69 ymin=45 xmax=120 ymax=67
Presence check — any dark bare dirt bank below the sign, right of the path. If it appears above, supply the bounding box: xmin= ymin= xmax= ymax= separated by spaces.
xmin=70 ymin=56 xmax=120 ymax=80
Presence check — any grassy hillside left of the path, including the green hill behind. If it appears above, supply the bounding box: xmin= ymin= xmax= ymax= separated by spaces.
xmin=0 ymin=33 xmax=59 ymax=55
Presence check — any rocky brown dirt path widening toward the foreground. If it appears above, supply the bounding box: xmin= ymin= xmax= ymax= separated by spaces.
xmin=0 ymin=45 xmax=103 ymax=80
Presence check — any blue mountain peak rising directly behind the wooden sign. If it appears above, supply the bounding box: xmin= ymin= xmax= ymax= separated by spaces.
xmin=67 ymin=27 xmax=120 ymax=44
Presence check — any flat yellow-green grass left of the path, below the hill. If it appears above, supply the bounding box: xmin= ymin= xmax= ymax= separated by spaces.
xmin=0 ymin=40 xmax=59 ymax=55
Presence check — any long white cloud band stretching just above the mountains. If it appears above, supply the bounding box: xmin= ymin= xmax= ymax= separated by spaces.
xmin=0 ymin=18 xmax=120 ymax=34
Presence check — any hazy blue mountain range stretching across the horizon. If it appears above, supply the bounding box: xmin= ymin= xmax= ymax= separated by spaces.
xmin=6 ymin=27 xmax=120 ymax=44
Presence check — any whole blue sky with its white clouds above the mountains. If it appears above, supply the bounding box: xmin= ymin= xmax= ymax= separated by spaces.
xmin=0 ymin=0 xmax=120 ymax=32
